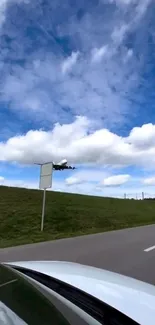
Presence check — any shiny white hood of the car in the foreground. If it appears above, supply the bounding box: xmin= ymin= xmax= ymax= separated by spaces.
xmin=5 ymin=261 xmax=155 ymax=325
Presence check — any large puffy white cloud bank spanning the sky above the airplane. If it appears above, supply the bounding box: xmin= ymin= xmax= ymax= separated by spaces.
xmin=0 ymin=116 xmax=155 ymax=167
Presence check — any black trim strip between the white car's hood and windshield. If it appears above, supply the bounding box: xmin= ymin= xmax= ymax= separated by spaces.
xmin=7 ymin=265 xmax=139 ymax=325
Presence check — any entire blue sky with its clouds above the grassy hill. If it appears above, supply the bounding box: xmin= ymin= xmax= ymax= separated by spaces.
xmin=0 ymin=0 xmax=155 ymax=197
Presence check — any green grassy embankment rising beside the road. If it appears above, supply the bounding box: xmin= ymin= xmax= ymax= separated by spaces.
xmin=0 ymin=186 xmax=155 ymax=247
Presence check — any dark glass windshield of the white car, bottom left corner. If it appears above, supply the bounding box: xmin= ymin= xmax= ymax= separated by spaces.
xmin=0 ymin=266 xmax=70 ymax=325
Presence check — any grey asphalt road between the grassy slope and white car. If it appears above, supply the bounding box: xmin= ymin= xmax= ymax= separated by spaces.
xmin=0 ymin=225 xmax=155 ymax=285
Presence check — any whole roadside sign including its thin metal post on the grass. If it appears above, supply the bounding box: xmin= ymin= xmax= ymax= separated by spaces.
xmin=39 ymin=163 xmax=53 ymax=231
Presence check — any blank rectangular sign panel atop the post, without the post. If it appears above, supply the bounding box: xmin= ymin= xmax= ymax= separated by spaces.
xmin=39 ymin=163 xmax=53 ymax=189
